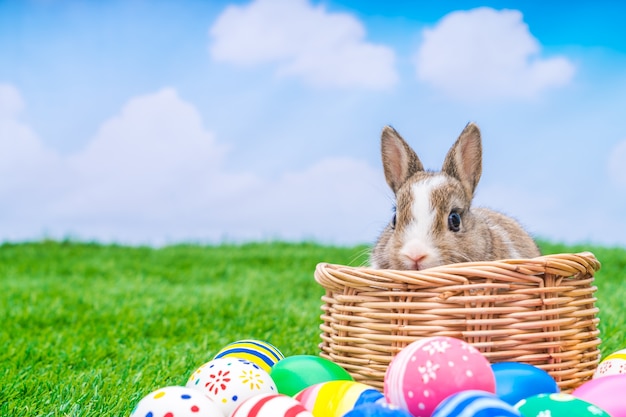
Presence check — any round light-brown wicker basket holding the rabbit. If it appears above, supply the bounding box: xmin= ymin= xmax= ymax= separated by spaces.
xmin=315 ymin=252 xmax=600 ymax=392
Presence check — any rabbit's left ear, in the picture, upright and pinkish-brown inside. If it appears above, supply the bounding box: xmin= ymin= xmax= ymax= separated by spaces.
xmin=380 ymin=126 xmax=424 ymax=193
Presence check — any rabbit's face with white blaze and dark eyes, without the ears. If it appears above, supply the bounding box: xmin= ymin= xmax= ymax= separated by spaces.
xmin=389 ymin=172 xmax=470 ymax=269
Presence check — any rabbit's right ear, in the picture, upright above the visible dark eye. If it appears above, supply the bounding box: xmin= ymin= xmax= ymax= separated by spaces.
xmin=442 ymin=123 xmax=483 ymax=200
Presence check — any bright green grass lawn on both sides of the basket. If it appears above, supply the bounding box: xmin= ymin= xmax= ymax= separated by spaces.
xmin=0 ymin=241 xmax=626 ymax=417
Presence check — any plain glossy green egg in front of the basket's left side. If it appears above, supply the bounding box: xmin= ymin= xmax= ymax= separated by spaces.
xmin=270 ymin=355 xmax=354 ymax=396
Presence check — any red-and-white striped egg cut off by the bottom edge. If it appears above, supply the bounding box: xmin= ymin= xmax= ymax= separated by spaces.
xmin=230 ymin=394 xmax=313 ymax=417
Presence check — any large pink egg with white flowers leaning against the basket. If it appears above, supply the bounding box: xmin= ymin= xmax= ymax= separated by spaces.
xmin=384 ymin=336 xmax=495 ymax=417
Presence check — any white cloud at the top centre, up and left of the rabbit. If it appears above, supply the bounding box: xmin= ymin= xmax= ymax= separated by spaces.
xmin=210 ymin=0 xmax=397 ymax=89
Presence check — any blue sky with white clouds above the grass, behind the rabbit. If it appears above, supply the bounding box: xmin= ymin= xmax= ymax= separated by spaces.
xmin=0 ymin=0 xmax=626 ymax=246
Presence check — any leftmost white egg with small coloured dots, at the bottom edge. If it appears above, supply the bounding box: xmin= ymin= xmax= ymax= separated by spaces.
xmin=130 ymin=386 xmax=225 ymax=417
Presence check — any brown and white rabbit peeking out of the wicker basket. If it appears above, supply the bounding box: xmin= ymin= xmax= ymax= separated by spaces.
xmin=370 ymin=123 xmax=540 ymax=270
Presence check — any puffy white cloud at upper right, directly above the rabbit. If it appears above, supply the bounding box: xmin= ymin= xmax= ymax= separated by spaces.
xmin=416 ymin=7 xmax=575 ymax=101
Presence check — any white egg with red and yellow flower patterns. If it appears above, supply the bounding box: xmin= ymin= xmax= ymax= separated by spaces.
xmin=186 ymin=358 xmax=277 ymax=416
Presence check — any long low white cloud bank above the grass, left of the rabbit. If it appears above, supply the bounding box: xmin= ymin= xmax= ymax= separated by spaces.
xmin=0 ymin=88 xmax=388 ymax=244
